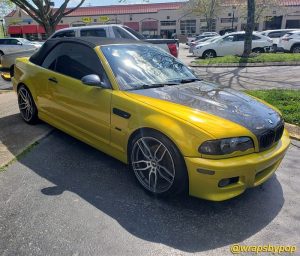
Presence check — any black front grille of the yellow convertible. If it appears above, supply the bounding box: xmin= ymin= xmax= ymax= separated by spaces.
xmin=259 ymin=123 xmax=284 ymax=151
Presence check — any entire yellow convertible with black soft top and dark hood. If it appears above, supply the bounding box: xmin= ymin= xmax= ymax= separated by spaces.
xmin=12 ymin=37 xmax=290 ymax=201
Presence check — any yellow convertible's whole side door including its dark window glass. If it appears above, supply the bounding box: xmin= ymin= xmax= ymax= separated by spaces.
xmin=42 ymin=42 xmax=112 ymax=145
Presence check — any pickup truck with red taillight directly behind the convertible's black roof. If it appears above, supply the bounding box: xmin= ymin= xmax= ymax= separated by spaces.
xmin=50 ymin=25 xmax=179 ymax=57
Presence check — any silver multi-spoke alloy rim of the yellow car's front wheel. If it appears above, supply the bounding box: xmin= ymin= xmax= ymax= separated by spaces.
xmin=131 ymin=137 xmax=175 ymax=194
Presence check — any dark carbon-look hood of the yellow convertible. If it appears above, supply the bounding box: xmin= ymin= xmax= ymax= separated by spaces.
xmin=128 ymin=81 xmax=283 ymax=136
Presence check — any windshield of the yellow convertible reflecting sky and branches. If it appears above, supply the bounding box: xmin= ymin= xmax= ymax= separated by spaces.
xmin=101 ymin=45 xmax=197 ymax=90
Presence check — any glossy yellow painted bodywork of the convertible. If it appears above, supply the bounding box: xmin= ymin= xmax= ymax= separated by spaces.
xmin=12 ymin=47 xmax=289 ymax=201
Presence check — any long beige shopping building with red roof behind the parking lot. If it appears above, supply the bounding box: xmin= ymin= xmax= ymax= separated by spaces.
xmin=5 ymin=0 xmax=300 ymax=40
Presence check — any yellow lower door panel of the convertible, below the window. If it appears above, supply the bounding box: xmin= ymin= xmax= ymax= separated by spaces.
xmin=48 ymin=72 xmax=111 ymax=143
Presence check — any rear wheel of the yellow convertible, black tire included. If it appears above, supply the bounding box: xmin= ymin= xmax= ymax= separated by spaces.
xmin=18 ymin=85 xmax=38 ymax=124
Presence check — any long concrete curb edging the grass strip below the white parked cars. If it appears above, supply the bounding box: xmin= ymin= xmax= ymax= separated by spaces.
xmin=189 ymin=61 xmax=300 ymax=68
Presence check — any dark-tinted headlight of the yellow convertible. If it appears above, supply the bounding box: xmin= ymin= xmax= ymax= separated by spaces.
xmin=198 ymin=137 xmax=254 ymax=155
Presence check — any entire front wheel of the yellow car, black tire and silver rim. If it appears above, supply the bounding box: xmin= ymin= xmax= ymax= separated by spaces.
xmin=128 ymin=129 xmax=188 ymax=197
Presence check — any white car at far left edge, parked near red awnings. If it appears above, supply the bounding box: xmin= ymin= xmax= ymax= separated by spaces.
xmin=0 ymin=37 xmax=41 ymax=60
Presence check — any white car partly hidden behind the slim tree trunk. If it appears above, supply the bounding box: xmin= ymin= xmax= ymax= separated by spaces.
xmin=193 ymin=32 xmax=273 ymax=58
